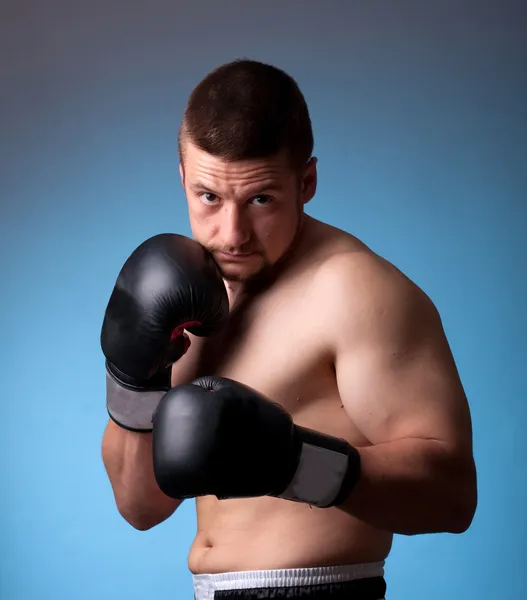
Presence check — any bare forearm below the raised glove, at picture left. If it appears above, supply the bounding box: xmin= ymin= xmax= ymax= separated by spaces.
xmin=102 ymin=420 xmax=181 ymax=529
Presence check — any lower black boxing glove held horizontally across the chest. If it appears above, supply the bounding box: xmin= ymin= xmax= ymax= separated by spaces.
xmin=152 ymin=377 xmax=360 ymax=508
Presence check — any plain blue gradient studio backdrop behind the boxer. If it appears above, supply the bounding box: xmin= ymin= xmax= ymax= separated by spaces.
xmin=0 ymin=0 xmax=527 ymax=600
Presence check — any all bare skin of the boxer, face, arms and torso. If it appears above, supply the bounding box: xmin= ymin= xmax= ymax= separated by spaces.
xmin=103 ymin=141 xmax=477 ymax=573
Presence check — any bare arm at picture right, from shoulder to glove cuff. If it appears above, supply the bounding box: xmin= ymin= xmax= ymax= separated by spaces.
xmin=326 ymin=253 xmax=477 ymax=535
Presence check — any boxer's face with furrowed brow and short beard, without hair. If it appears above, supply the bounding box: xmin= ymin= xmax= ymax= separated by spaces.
xmin=180 ymin=141 xmax=316 ymax=282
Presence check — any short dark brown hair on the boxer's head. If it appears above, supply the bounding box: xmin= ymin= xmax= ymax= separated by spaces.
xmin=178 ymin=59 xmax=313 ymax=168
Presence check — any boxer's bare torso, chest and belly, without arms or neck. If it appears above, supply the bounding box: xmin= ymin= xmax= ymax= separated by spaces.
xmin=173 ymin=218 xmax=392 ymax=573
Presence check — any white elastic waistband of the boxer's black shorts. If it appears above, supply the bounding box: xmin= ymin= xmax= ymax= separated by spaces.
xmin=193 ymin=561 xmax=384 ymax=600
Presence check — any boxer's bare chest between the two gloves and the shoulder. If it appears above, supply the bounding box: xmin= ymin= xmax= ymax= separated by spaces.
xmin=178 ymin=290 xmax=340 ymax=425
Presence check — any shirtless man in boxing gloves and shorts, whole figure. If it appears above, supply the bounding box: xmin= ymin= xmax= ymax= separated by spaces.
xmin=102 ymin=60 xmax=477 ymax=600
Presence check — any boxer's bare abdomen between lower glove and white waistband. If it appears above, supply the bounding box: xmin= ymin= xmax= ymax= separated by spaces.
xmin=188 ymin=497 xmax=392 ymax=573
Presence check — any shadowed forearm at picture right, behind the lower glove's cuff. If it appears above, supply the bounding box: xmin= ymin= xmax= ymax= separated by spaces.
xmin=340 ymin=439 xmax=476 ymax=535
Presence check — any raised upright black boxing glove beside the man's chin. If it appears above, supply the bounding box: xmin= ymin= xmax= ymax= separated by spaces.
xmin=101 ymin=233 xmax=229 ymax=431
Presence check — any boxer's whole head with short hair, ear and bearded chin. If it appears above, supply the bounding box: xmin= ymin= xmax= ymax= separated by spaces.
xmin=179 ymin=60 xmax=316 ymax=281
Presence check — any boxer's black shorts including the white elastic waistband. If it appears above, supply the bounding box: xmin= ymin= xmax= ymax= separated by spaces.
xmin=194 ymin=562 xmax=386 ymax=600
